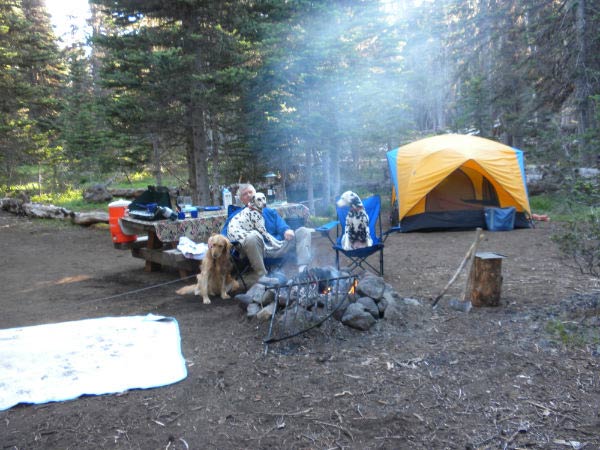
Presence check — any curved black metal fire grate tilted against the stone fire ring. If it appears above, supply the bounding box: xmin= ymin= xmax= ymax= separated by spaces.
xmin=263 ymin=269 xmax=358 ymax=355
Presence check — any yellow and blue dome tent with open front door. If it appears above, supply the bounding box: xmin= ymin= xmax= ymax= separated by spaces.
xmin=387 ymin=134 xmax=531 ymax=231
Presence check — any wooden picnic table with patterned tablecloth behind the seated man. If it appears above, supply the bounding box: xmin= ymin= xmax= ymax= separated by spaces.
xmin=114 ymin=203 xmax=309 ymax=277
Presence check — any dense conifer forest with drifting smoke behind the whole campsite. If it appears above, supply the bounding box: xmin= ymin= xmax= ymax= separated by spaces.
xmin=0 ymin=0 xmax=600 ymax=204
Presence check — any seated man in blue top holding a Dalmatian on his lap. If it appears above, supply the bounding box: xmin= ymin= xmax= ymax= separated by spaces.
xmin=222 ymin=184 xmax=312 ymax=284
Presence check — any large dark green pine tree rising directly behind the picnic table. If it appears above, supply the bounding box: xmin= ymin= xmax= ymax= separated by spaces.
xmin=90 ymin=0 xmax=256 ymax=204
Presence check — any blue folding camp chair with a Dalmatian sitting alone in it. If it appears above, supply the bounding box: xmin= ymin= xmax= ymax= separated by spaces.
xmin=317 ymin=195 xmax=397 ymax=277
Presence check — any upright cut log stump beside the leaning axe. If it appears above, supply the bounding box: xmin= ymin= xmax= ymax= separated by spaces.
xmin=469 ymin=252 xmax=504 ymax=306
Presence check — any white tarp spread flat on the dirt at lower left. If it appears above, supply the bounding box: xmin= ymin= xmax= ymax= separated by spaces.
xmin=0 ymin=314 xmax=187 ymax=411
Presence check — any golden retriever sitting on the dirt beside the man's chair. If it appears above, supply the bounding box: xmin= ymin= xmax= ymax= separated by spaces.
xmin=176 ymin=234 xmax=239 ymax=305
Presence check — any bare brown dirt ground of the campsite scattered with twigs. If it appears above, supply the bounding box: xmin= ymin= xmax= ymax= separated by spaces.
xmin=0 ymin=212 xmax=600 ymax=450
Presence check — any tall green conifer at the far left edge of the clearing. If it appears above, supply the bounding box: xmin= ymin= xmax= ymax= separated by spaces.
xmin=0 ymin=0 xmax=63 ymax=186
